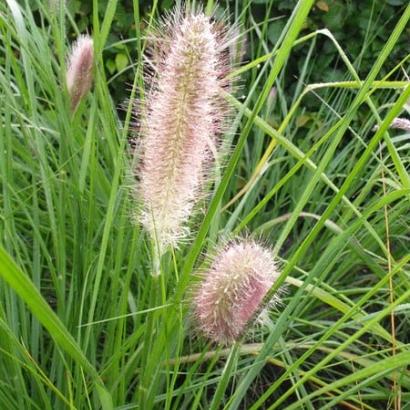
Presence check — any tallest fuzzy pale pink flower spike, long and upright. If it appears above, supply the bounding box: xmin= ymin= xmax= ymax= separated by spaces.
xmin=136 ymin=11 xmax=235 ymax=254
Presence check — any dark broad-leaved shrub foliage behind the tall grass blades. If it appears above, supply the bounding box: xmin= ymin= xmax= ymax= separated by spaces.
xmin=42 ymin=0 xmax=410 ymax=105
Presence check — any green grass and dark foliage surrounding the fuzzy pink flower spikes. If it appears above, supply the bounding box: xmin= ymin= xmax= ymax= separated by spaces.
xmin=0 ymin=0 xmax=410 ymax=410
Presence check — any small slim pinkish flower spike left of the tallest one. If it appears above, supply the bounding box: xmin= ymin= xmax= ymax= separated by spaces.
xmin=66 ymin=35 xmax=94 ymax=111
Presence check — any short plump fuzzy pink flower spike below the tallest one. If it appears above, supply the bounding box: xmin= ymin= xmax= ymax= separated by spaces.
xmin=193 ymin=240 xmax=280 ymax=344
